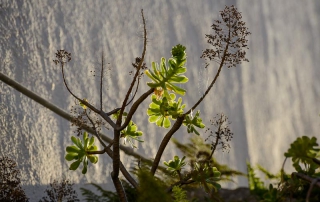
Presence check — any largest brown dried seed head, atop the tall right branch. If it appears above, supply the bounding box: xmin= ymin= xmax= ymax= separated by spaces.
xmin=201 ymin=6 xmax=251 ymax=68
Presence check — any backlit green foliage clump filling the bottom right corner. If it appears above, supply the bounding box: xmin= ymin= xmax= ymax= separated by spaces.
xmin=247 ymin=136 xmax=320 ymax=202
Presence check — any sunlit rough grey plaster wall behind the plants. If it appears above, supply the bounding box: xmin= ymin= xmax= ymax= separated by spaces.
xmin=0 ymin=0 xmax=320 ymax=200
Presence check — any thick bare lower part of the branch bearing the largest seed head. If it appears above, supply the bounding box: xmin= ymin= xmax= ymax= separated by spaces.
xmin=151 ymin=115 xmax=184 ymax=175
